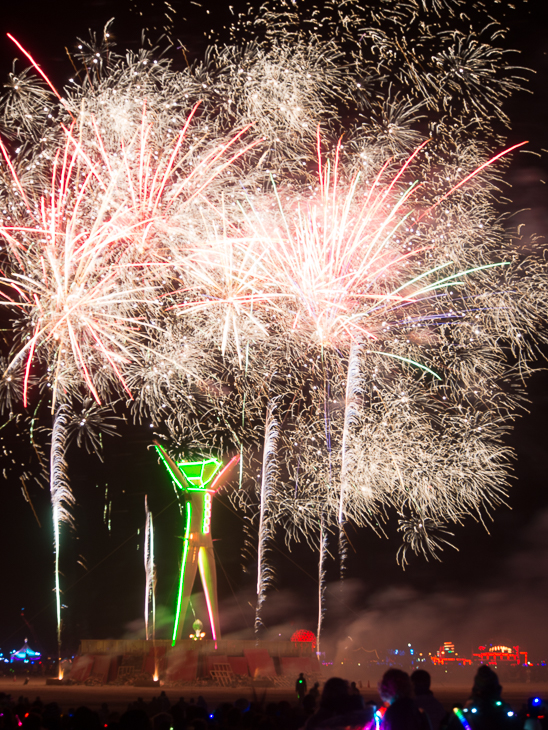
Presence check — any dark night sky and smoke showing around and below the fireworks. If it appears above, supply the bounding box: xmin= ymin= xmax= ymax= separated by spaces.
xmin=0 ymin=0 xmax=548 ymax=660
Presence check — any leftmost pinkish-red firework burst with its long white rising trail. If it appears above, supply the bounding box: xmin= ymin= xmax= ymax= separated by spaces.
xmin=0 ymin=42 xmax=264 ymax=643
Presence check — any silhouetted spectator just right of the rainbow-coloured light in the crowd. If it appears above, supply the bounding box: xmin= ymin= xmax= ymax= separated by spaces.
xmin=379 ymin=669 xmax=432 ymax=730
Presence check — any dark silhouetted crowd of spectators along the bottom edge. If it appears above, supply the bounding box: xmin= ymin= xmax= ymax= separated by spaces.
xmin=0 ymin=666 xmax=548 ymax=730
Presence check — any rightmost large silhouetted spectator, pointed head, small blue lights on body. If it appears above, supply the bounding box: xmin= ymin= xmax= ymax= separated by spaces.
xmin=447 ymin=664 xmax=520 ymax=730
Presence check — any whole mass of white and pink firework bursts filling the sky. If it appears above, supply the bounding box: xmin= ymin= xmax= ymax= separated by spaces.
xmin=0 ymin=0 xmax=548 ymax=628
